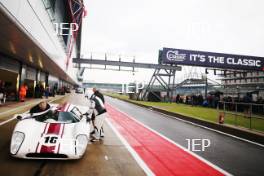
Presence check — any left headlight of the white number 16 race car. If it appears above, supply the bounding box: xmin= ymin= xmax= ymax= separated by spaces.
xmin=10 ymin=131 xmax=25 ymax=155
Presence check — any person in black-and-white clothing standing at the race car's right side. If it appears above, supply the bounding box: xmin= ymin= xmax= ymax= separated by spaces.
xmin=90 ymin=94 xmax=107 ymax=142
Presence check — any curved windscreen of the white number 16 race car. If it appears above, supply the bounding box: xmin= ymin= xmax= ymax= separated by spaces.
xmin=33 ymin=110 xmax=80 ymax=123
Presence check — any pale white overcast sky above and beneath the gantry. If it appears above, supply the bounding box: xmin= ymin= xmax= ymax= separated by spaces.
xmin=82 ymin=0 xmax=264 ymax=83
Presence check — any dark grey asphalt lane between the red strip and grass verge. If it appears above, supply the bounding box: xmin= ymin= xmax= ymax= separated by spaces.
xmin=106 ymin=98 xmax=264 ymax=176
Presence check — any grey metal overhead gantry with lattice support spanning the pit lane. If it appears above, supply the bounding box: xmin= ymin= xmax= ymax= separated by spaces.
xmin=73 ymin=55 xmax=181 ymax=101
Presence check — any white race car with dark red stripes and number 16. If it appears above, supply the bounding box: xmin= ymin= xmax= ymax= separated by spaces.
xmin=10 ymin=103 xmax=91 ymax=159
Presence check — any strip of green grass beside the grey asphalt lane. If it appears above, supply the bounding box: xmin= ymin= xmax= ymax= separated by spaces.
xmin=106 ymin=93 xmax=264 ymax=132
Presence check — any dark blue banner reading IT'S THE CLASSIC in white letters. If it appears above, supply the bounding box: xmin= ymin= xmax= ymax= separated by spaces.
xmin=162 ymin=48 xmax=264 ymax=71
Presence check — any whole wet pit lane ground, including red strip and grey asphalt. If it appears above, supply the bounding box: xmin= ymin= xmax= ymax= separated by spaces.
xmin=0 ymin=94 xmax=264 ymax=176
